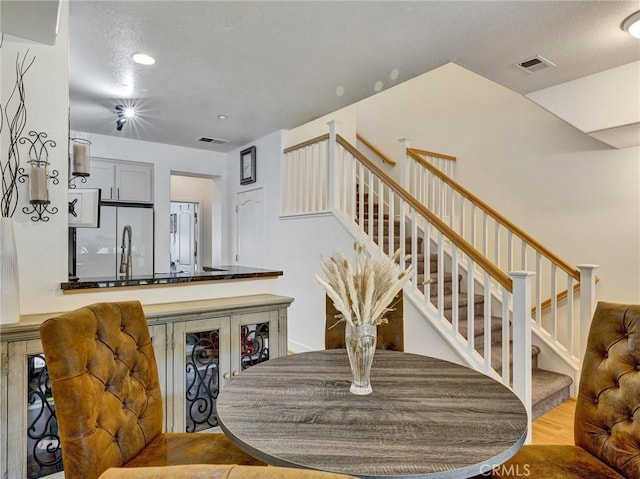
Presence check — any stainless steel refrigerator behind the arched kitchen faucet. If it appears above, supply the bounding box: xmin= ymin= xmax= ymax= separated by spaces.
xmin=75 ymin=204 xmax=153 ymax=279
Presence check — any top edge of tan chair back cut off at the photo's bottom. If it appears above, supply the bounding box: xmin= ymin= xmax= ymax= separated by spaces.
xmin=100 ymin=464 xmax=355 ymax=479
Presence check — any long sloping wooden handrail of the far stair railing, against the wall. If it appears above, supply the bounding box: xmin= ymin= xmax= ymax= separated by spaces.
xmin=407 ymin=148 xmax=580 ymax=281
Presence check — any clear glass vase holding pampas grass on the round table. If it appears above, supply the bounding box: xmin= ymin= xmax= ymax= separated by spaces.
xmin=345 ymin=323 xmax=377 ymax=396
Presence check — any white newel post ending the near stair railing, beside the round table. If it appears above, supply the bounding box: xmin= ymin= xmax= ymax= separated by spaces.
xmin=509 ymin=271 xmax=534 ymax=442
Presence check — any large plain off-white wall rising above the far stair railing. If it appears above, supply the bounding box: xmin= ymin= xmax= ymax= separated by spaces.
xmin=357 ymin=64 xmax=640 ymax=303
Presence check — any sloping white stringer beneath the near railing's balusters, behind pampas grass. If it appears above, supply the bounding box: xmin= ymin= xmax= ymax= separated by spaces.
xmin=333 ymin=210 xmax=501 ymax=381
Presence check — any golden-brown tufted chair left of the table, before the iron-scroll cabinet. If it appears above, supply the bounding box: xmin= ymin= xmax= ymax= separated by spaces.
xmin=40 ymin=301 xmax=263 ymax=479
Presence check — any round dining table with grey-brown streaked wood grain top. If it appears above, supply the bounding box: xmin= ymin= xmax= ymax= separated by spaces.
xmin=217 ymin=349 xmax=527 ymax=479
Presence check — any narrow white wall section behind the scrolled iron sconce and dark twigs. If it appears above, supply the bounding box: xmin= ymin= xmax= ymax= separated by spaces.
xmin=0 ymin=2 xmax=69 ymax=318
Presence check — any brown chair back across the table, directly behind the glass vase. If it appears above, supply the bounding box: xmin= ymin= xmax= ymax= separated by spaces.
xmin=324 ymin=291 xmax=404 ymax=351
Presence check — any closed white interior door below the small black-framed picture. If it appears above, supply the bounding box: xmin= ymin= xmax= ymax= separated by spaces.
xmin=236 ymin=188 xmax=267 ymax=268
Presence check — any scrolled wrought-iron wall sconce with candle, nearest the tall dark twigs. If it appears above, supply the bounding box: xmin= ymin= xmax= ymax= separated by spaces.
xmin=18 ymin=131 xmax=59 ymax=221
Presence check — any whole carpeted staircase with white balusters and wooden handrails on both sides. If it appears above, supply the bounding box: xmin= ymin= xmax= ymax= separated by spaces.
xmin=282 ymin=130 xmax=596 ymax=424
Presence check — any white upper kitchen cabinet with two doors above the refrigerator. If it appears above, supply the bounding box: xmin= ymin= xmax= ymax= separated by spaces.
xmin=83 ymin=158 xmax=153 ymax=203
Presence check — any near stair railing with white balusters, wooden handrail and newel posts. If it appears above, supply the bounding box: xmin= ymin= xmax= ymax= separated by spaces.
xmin=282 ymin=124 xmax=531 ymax=428
